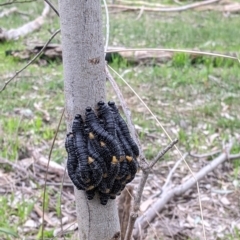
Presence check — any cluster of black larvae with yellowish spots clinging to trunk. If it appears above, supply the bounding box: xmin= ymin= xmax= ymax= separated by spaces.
xmin=65 ymin=101 xmax=139 ymax=205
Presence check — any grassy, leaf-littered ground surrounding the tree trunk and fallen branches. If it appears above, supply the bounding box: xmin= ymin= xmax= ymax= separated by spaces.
xmin=0 ymin=0 xmax=240 ymax=239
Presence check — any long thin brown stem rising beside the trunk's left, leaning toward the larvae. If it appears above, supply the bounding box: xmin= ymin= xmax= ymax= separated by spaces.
xmin=41 ymin=108 xmax=65 ymax=240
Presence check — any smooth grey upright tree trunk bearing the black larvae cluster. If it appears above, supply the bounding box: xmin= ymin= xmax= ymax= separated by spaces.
xmin=59 ymin=0 xmax=120 ymax=240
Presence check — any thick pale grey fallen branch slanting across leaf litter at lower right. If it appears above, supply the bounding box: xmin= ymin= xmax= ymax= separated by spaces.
xmin=135 ymin=142 xmax=234 ymax=237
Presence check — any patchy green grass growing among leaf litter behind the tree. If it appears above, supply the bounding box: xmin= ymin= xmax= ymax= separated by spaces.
xmin=0 ymin=2 xmax=240 ymax=239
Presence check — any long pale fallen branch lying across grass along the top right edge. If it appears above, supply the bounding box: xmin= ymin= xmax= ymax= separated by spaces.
xmin=108 ymin=0 xmax=220 ymax=12
